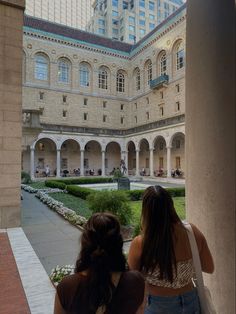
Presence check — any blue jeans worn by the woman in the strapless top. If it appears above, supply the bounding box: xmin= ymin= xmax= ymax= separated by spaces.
xmin=144 ymin=289 xmax=201 ymax=314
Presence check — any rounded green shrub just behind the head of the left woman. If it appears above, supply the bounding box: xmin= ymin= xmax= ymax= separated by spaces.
xmin=87 ymin=191 xmax=132 ymax=225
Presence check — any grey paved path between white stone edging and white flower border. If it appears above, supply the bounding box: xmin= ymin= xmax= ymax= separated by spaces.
xmin=21 ymin=191 xmax=81 ymax=274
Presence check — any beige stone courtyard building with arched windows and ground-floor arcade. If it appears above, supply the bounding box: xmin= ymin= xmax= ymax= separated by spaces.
xmin=22 ymin=6 xmax=186 ymax=177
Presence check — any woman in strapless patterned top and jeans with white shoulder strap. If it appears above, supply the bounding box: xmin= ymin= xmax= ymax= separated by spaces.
xmin=128 ymin=186 xmax=214 ymax=314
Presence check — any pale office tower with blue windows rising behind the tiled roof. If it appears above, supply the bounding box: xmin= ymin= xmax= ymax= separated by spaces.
xmin=86 ymin=0 xmax=184 ymax=43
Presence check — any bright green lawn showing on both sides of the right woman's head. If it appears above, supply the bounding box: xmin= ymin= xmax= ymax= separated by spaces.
xmin=130 ymin=197 xmax=185 ymax=225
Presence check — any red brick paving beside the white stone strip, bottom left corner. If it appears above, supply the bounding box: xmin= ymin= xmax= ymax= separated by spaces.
xmin=0 ymin=232 xmax=30 ymax=314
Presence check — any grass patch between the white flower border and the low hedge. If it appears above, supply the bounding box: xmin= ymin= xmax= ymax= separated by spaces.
xmin=48 ymin=193 xmax=91 ymax=218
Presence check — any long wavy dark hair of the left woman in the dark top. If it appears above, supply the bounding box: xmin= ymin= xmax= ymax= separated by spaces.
xmin=75 ymin=213 xmax=127 ymax=313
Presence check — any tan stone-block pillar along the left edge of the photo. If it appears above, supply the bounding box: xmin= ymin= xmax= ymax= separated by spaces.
xmin=0 ymin=0 xmax=25 ymax=229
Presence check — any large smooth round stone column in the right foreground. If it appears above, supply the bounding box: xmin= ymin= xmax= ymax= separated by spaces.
xmin=186 ymin=0 xmax=236 ymax=314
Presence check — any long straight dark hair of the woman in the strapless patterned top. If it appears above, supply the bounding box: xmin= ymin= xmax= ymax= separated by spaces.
xmin=141 ymin=186 xmax=181 ymax=282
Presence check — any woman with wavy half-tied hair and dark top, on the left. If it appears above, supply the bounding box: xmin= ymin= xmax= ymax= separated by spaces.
xmin=54 ymin=213 xmax=144 ymax=314
